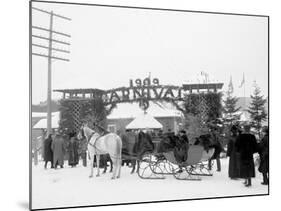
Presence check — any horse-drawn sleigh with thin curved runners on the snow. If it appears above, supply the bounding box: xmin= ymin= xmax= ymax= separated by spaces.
xmin=138 ymin=145 xmax=214 ymax=180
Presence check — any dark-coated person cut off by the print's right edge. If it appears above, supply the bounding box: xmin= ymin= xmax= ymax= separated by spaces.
xmin=258 ymin=127 xmax=269 ymax=185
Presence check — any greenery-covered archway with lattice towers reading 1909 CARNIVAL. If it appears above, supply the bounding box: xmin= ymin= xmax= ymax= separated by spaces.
xmin=54 ymin=78 xmax=223 ymax=134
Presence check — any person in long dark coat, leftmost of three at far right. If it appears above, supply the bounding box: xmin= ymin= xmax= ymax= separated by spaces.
xmin=226 ymin=125 xmax=239 ymax=179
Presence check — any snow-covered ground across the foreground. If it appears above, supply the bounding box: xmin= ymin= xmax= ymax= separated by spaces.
xmin=32 ymin=158 xmax=268 ymax=209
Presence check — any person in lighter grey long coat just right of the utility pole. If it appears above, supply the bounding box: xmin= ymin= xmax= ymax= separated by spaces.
xmin=52 ymin=134 xmax=65 ymax=169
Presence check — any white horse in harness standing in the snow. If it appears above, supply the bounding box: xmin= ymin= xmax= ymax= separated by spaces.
xmin=78 ymin=124 xmax=122 ymax=179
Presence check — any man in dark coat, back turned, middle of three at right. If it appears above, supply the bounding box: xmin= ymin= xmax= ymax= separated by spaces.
xmin=235 ymin=125 xmax=258 ymax=187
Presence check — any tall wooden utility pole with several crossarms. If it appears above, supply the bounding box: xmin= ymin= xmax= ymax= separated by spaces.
xmin=32 ymin=7 xmax=71 ymax=136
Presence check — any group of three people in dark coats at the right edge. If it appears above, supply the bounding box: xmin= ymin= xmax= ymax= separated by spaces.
xmin=224 ymin=125 xmax=269 ymax=187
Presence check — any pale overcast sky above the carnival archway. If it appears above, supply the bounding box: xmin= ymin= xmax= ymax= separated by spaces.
xmin=32 ymin=2 xmax=268 ymax=103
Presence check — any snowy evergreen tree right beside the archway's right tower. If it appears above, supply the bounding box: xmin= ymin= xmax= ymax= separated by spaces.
xmin=223 ymin=78 xmax=240 ymax=125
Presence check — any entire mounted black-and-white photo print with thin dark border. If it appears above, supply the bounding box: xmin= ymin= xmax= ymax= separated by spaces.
xmin=29 ymin=1 xmax=269 ymax=210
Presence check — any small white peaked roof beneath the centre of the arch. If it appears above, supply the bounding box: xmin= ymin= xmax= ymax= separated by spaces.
xmin=126 ymin=113 xmax=163 ymax=129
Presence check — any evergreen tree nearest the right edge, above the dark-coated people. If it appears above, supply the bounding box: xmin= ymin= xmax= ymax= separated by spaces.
xmin=247 ymin=83 xmax=267 ymax=138
